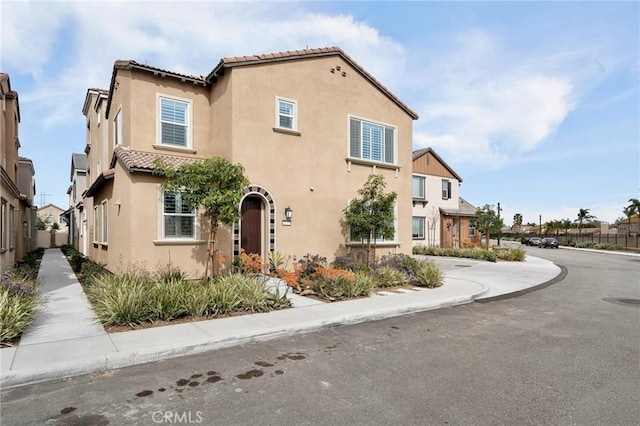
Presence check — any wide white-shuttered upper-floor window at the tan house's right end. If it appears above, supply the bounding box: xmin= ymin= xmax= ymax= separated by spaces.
xmin=349 ymin=117 xmax=396 ymax=164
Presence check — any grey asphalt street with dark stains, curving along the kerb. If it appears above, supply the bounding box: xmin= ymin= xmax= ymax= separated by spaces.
xmin=0 ymin=248 xmax=640 ymax=425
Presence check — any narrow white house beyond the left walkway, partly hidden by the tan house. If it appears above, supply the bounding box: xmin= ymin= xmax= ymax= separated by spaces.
xmin=62 ymin=153 xmax=88 ymax=255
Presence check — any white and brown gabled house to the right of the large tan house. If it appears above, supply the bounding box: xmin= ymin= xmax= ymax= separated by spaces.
xmin=412 ymin=148 xmax=479 ymax=247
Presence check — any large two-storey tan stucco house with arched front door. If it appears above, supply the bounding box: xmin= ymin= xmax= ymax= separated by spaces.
xmin=83 ymin=47 xmax=418 ymax=274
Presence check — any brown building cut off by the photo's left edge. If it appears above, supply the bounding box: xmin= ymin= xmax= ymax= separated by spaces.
xmin=0 ymin=73 xmax=36 ymax=269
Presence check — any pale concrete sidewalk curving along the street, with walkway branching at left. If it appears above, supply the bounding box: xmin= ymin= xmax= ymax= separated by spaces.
xmin=0 ymin=249 xmax=561 ymax=387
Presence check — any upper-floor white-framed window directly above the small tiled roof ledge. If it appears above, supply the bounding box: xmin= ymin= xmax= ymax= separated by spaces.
xmin=157 ymin=95 xmax=191 ymax=148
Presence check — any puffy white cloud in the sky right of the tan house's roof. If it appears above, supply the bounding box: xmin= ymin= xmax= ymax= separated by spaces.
xmin=414 ymin=30 xmax=575 ymax=168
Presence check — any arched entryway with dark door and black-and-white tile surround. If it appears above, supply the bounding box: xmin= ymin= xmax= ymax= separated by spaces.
xmin=233 ymin=185 xmax=276 ymax=257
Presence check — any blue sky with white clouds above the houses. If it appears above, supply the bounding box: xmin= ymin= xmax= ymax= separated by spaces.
xmin=0 ymin=0 xmax=640 ymax=225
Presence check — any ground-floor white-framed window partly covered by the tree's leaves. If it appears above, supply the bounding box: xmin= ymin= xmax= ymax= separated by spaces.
xmin=162 ymin=192 xmax=196 ymax=239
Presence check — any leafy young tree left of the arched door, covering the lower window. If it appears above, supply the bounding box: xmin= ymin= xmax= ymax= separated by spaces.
xmin=154 ymin=157 xmax=249 ymax=277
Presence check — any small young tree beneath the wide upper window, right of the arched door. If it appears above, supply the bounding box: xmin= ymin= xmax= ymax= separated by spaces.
xmin=344 ymin=174 xmax=398 ymax=264
